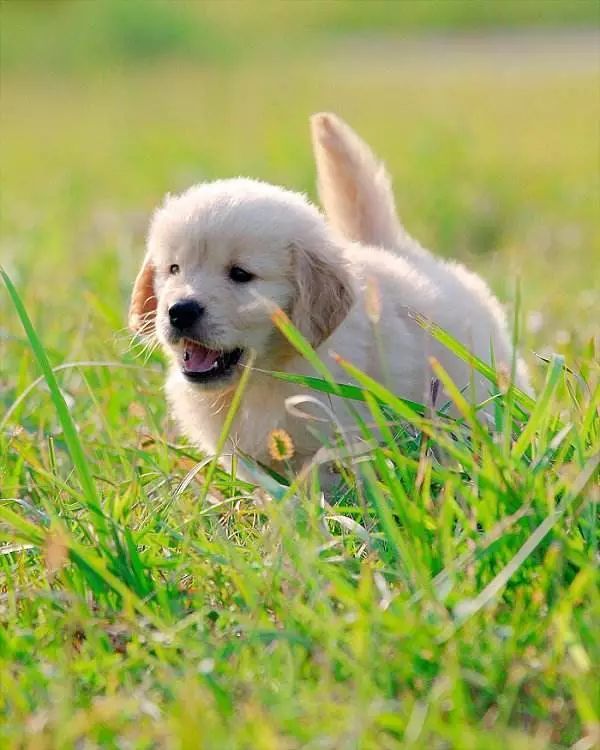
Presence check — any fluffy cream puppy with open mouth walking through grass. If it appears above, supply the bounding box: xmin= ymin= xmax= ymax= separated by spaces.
xmin=129 ymin=114 xmax=527 ymax=476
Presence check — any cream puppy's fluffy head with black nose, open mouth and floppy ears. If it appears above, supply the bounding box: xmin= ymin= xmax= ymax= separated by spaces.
xmin=129 ymin=179 xmax=353 ymax=388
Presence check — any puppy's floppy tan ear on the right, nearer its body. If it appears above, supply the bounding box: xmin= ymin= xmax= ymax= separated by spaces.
xmin=290 ymin=245 xmax=354 ymax=348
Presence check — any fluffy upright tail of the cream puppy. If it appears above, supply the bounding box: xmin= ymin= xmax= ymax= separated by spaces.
xmin=311 ymin=112 xmax=405 ymax=250
